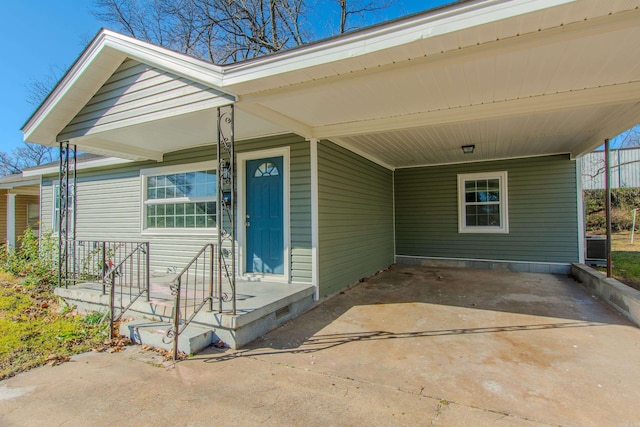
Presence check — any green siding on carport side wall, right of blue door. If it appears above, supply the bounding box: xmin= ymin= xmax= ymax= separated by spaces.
xmin=318 ymin=141 xmax=393 ymax=297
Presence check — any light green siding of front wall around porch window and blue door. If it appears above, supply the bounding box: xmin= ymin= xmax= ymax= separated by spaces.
xmin=41 ymin=136 xmax=311 ymax=283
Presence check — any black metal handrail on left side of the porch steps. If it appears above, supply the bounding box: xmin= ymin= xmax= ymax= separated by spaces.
xmin=107 ymin=242 xmax=150 ymax=338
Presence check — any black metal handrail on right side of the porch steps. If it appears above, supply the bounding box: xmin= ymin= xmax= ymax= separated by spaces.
xmin=163 ymin=243 xmax=228 ymax=360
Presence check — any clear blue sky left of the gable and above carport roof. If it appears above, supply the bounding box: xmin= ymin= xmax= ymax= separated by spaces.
xmin=0 ymin=0 xmax=451 ymax=152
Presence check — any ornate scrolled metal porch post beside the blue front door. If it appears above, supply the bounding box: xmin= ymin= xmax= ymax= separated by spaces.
xmin=216 ymin=105 xmax=236 ymax=314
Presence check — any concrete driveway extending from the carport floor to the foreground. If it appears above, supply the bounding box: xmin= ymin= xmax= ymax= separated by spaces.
xmin=0 ymin=266 xmax=640 ymax=426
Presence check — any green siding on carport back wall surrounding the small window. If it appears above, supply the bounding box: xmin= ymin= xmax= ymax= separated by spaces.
xmin=395 ymin=155 xmax=579 ymax=263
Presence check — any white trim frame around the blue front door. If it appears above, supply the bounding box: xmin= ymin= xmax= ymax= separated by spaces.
xmin=236 ymin=146 xmax=291 ymax=283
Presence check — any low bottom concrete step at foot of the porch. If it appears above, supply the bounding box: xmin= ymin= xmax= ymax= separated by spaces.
xmin=120 ymin=320 xmax=219 ymax=354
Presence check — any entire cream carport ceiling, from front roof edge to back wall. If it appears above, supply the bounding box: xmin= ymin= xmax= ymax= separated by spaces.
xmin=226 ymin=1 xmax=640 ymax=167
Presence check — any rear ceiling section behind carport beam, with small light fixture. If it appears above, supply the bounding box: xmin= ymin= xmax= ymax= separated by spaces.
xmin=332 ymin=103 xmax=640 ymax=168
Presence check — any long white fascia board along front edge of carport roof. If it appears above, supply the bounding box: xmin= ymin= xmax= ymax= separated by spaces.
xmin=224 ymin=0 xmax=576 ymax=89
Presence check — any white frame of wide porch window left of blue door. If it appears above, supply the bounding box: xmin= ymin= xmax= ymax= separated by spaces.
xmin=140 ymin=160 xmax=219 ymax=236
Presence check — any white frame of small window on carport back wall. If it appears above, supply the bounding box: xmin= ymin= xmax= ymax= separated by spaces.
xmin=458 ymin=171 xmax=509 ymax=234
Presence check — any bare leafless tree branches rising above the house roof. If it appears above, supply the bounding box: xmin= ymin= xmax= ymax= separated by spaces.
xmin=94 ymin=0 xmax=388 ymax=63
